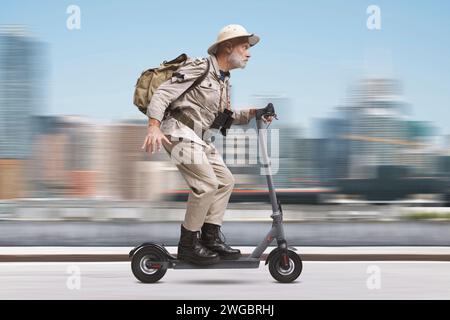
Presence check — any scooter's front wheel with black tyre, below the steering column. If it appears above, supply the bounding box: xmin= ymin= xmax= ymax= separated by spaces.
xmin=269 ymin=250 xmax=303 ymax=283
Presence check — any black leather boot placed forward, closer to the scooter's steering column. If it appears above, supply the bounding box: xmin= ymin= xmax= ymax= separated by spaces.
xmin=202 ymin=223 xmax=241 ymax=260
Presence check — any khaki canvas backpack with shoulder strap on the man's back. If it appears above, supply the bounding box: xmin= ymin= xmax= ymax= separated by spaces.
xmin=133 ymin=53 xmax=209 ymax=115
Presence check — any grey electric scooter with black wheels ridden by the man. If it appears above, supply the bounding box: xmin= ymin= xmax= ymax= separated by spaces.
xmin=129 ymin=103 xmax=303 ymax=283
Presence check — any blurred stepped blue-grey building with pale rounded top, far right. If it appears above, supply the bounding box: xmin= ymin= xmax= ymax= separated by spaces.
xmin=321 ymin=78 xmax=446 ymax=200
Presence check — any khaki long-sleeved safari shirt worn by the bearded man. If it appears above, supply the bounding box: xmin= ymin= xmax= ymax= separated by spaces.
xmin=147 ymin=56 xmax=250 ymax=145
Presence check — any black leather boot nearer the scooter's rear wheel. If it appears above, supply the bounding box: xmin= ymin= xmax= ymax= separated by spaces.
xmin=177 ymin=225 xmax=220 ymax=265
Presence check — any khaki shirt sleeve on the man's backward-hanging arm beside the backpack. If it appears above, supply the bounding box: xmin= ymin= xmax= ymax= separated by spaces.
xmin=147 ymin=59 xmax=207 ymax=122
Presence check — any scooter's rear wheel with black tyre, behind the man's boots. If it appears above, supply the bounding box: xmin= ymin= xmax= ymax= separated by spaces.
xmin=131 ymin=248 xmax=168 ymax=283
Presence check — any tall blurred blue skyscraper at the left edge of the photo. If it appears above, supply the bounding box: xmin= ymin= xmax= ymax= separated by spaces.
xmin=0 ymin=26 xmax=47 ymax=199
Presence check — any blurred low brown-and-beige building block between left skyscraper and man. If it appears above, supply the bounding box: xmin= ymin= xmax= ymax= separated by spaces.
xmin=32 ymin=116 xmax=181 ymax=200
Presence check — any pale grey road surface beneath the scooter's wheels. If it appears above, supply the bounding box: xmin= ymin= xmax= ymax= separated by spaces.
xmin=0 ymin=261 xmax=450 ymax=300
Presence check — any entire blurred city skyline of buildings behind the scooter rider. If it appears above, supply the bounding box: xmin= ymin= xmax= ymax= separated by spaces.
xmin=0 ymin=26 xmax=449 ymax=200
